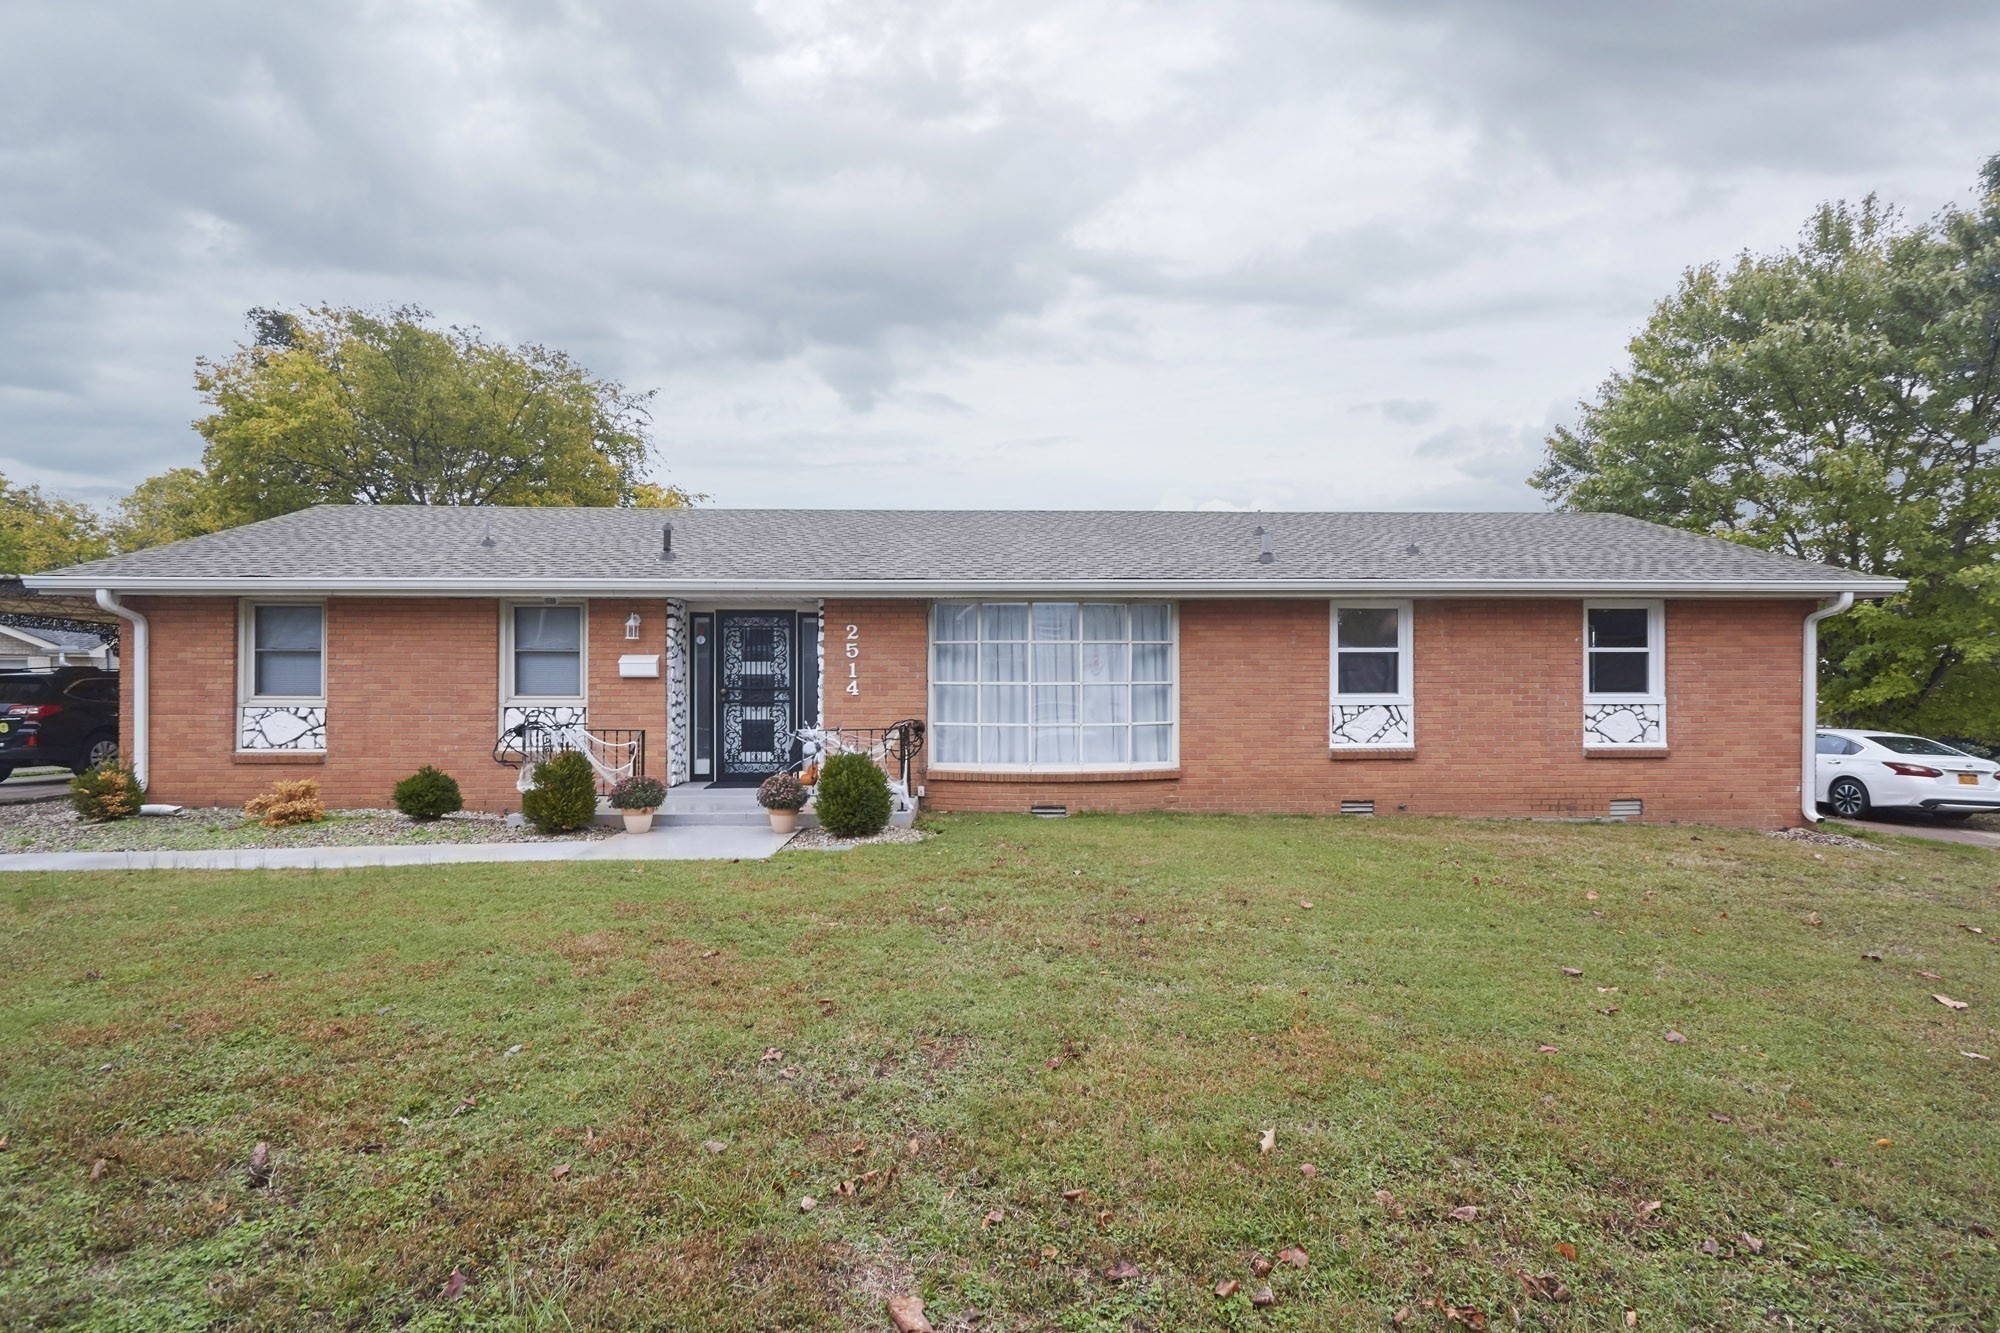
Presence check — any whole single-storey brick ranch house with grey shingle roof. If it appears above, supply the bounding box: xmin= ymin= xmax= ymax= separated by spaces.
xmin=28 ymin=506 xmax=1902 ymax=829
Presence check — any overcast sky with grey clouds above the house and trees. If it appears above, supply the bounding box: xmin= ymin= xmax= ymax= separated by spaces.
xmin=0 ymin=0 xmax=2000 ymax=508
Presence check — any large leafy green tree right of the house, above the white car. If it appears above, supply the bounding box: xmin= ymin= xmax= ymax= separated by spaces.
xmin=1530 ymin=158 xmax=2000 ymax=739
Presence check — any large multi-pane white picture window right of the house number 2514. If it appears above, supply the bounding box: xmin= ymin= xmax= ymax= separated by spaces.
xmin=930 ymin=602 xmax=1178 ymax=771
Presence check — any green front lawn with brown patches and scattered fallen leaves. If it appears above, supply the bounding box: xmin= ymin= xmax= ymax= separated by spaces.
xmin=0 ymin=817 xmax=2000 ymax=1329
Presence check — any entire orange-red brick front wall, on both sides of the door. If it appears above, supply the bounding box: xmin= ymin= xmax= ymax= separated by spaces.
xmin=124 ymin=598 xmax=1810 ymax=827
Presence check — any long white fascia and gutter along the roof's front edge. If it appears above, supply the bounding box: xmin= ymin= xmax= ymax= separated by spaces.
xmin=24 ymin=574 xmax=1908 ymax=598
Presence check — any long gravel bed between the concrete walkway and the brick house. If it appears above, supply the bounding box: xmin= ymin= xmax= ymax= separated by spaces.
xmin=0 ymin=803 xmax=614 ymax=853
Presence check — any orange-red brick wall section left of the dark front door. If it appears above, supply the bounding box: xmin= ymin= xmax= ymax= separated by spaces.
xmin=120 ymin=596 xmax=666 ymax=811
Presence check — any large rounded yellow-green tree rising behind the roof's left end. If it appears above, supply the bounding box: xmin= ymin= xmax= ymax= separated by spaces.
xmin=193 ymin=306 xmax=692 ymax=526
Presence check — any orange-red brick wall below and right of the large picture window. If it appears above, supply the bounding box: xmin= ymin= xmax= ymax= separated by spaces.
xmin=900 ymin=600 xmax=1810 ymax=829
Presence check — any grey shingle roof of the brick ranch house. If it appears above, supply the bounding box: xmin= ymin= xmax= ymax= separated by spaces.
xmin=28 ymin=504 xmax=1902 ymax=596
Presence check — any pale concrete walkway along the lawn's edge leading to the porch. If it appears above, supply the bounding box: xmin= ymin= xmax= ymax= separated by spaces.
xmin=0 ymin=825 xmax=790 ymax=871
